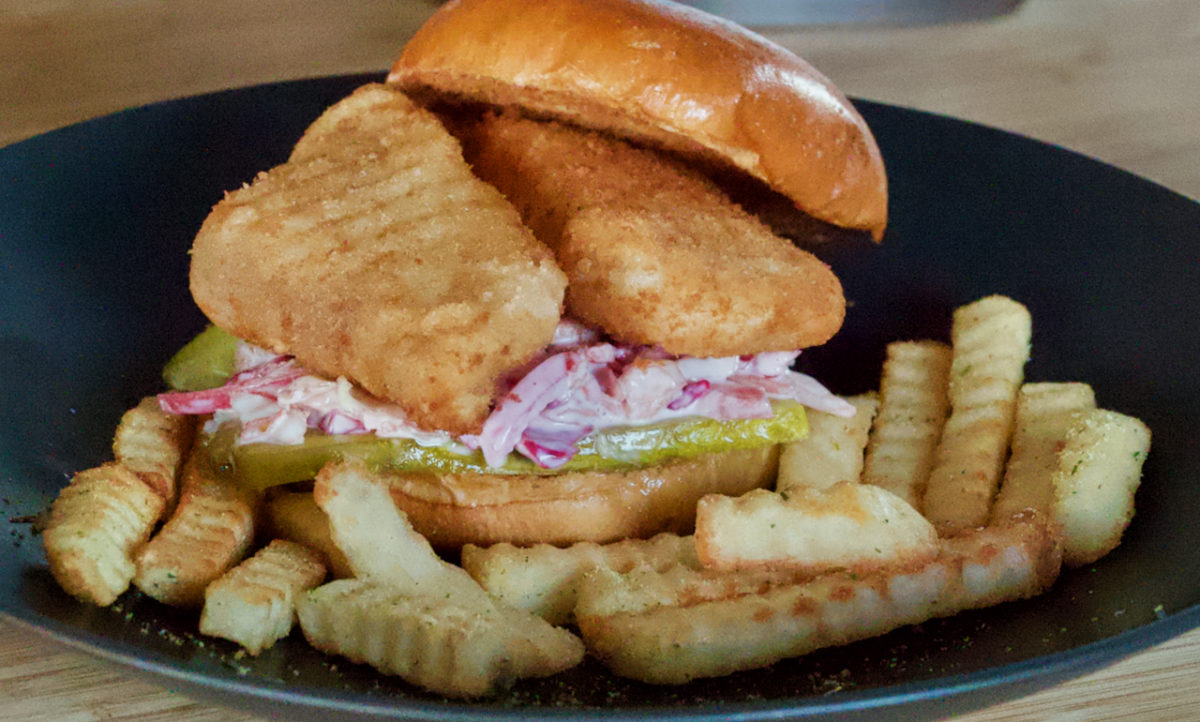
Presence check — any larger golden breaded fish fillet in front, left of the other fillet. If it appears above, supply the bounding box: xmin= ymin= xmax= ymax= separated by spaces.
xmin=191 ymin=84 xmax=566 ymax=433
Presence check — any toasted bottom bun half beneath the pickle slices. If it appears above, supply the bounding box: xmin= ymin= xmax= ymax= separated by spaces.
xmin=384 ymin=446 xmax=779 ymax=548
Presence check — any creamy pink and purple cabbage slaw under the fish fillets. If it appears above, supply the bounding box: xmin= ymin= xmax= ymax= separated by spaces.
xmin=158 ymin=320 xmax=854 ymax=469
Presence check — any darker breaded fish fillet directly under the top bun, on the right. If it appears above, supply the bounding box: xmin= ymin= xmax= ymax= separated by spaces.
xmin=451 ymin=114 xmax=845 ymax=356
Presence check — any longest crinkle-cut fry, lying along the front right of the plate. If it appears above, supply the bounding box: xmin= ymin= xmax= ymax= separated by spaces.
xmin=576 ymin=508 xmax=1062 ymax=684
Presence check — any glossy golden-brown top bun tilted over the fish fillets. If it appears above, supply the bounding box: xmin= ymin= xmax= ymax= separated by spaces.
xmin=388 ymin=0 xmax=887 ymax=239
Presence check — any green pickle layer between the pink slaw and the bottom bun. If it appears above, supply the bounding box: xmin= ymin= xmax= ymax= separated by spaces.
xmin=205 ymin=401 xmax=809 ymax=489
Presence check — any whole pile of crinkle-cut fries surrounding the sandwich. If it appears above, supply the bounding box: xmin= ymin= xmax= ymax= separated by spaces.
xmin=43 ymin=296 xmax=1150 ymax=698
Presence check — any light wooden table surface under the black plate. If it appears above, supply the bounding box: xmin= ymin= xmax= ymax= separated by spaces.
xmin=0 ymin=0 xmax=1200 ymax=721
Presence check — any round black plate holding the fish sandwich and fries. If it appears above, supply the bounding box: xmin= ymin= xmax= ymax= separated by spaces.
xmin=0 ymin=76 xmax=1200 ymax=720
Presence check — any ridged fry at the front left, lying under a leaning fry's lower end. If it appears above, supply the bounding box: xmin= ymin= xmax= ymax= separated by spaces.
xmin=298 ymin=579 xmax=583 ymax=698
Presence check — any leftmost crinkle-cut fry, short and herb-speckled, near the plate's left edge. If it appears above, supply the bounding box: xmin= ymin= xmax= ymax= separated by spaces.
xmin=42 ymin=463 xmax=164 ymax=607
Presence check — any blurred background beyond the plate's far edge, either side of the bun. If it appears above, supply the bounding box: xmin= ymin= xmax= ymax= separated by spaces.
xmin=0 ymin=0 xmax=1200 ymax=198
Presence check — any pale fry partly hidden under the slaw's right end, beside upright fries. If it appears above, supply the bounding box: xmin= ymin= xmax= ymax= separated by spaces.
xmin=775 ymin=392 xmax=878 ymax=492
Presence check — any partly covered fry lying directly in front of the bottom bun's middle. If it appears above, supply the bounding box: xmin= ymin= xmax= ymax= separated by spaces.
xmin=462 ymin=534 xmax=700 ymax=625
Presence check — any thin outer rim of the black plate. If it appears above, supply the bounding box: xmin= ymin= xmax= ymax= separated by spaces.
xmin=0 ymin=71 xmax=1200 ymax=720
